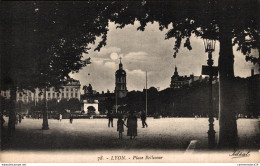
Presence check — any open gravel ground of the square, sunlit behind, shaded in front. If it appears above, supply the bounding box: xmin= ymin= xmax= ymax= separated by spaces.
xmin=1 ymin=118 xmax=260 ymax=151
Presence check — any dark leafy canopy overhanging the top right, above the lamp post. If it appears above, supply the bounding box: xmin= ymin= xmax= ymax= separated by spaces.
xmin=107 ymin=0 xmax=260 ymax=64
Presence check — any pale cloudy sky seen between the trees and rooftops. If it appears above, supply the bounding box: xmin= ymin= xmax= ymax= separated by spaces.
xmin=71 ymin=22 xmax=257 ymax=92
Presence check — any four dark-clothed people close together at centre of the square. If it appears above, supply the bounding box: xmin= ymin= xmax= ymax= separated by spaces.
xmin=107 ymin=111 xmax=148 ymax=139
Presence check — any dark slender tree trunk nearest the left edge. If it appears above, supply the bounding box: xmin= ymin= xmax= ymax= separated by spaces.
xmin=8 ymin=86 xmax=16 ymax=135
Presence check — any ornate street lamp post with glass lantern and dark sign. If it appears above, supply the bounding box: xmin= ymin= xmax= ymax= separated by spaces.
xmin=202 ymin=39 xmax=218 ymax=149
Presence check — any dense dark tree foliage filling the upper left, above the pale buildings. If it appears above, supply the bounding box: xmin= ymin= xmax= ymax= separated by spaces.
xmin=1 ymin=2 xmax=108 ymax=90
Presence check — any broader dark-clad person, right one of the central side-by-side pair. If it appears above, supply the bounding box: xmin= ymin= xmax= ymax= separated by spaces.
xmin=127 ymin=112 xmax=137 ymax=139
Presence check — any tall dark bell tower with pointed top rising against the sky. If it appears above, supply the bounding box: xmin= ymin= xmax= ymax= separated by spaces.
xmin=115 ymin=58 xmax=127 ymax=98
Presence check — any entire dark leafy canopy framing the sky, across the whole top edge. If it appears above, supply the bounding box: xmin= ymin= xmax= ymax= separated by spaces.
xmin=1 ymin=0 xmax=260 ymax=89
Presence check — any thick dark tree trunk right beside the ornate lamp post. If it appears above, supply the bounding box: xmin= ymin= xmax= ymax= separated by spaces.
xmin=218 ymin=24 xmax=238 ymax=149
